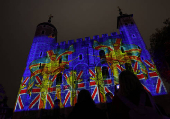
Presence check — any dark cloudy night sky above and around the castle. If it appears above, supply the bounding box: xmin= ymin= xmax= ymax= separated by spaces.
xmin=0 ymin=0 xmax=170 ymax=108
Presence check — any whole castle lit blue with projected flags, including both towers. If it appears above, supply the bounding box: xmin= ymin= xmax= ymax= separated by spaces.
xmin=14 ymin=9 xmax=167 ymax=112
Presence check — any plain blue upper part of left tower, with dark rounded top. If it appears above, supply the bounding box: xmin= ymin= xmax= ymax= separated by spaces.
xmin=24 ymin=15 xmax=57 ymax=77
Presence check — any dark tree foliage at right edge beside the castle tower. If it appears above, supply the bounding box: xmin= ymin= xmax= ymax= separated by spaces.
xmin=150 ymin=18 xmax=170 ymax=83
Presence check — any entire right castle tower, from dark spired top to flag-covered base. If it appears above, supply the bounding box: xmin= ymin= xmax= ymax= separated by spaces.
xmin=117 ymin=7 xmax=166 ymax=95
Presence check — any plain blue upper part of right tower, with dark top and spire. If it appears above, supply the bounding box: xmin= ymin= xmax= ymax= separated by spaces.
xmin=117 ymin=7 xmax=150 ymax=59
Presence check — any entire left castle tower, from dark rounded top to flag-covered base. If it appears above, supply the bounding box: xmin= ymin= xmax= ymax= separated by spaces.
xmin=15 ymin=15 xmax=57 ymax=111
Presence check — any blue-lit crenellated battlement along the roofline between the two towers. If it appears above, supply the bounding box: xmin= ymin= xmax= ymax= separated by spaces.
xmin=55 ymin=32 xmax=121 ymax=46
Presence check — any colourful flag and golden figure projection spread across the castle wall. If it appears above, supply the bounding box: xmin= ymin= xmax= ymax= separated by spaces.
xmin=15 ymin=38 xmax=166 ymax=111
